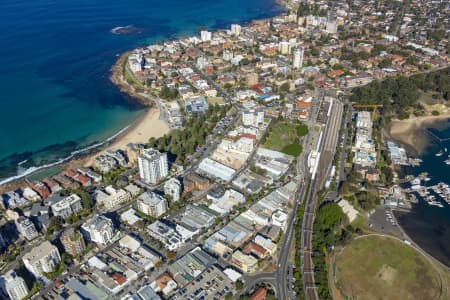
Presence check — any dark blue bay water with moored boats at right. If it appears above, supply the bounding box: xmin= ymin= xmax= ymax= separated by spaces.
xmin=396 ymin=120 xmax=450 ymax=267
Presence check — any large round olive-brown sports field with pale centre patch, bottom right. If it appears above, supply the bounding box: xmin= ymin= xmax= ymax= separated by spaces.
xmin=335 ymin=236 xmax=440 ymax=300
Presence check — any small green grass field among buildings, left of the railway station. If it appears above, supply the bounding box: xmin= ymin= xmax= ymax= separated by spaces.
xmin=263 ymin=121 xmax=308 ymax=156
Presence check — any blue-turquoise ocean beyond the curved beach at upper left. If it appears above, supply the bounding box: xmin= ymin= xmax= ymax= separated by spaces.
xmin=0 ymin=0 xmax=282 ymax=178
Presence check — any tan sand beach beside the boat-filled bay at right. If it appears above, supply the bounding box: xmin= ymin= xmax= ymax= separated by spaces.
xmin=389 ymin=112 xmax=450 ymax=154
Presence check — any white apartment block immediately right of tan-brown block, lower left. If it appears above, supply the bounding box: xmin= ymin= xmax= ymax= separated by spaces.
xmin=81 ymin=215 xmax=114 ymax=245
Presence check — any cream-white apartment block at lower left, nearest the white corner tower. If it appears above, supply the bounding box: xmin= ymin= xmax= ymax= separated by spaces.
xmin=22 ymin=241 xmax=61 ymax=278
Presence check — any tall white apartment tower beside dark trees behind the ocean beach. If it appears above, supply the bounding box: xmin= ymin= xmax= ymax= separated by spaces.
xmin=138 ymin=149 xmax=169 ymax=184
